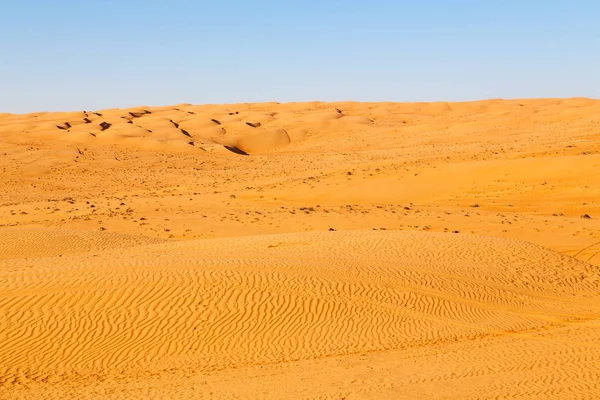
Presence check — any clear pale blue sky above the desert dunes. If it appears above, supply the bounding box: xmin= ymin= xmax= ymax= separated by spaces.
xmin=0 ymin=0 xmax=600 ymax=113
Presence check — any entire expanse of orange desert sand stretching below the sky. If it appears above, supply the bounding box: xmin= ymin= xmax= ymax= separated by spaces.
xmin=0 ymin=99 xmax=600 ymax=399
